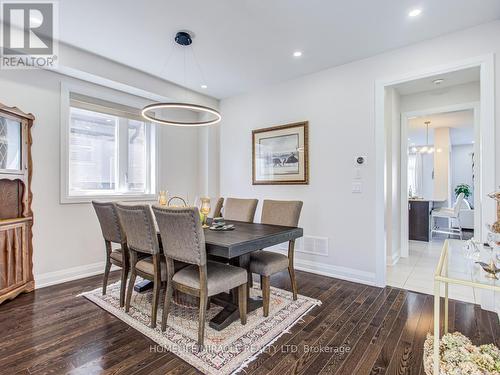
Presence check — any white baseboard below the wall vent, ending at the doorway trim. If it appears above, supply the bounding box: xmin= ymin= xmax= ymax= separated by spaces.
xmin=294 ymin=258 xmax=375 ymax=286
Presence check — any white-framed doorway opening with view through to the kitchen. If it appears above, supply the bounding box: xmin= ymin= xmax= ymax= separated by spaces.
xmin=376 ymin=56 xmax=495 ymax=302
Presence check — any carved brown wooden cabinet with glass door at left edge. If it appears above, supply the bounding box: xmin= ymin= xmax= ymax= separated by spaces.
xmin=0 ymin=104 xmax=35 ymax=303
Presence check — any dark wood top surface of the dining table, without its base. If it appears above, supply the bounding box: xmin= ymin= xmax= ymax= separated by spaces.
xmin=205 ymin=220 xmax=303 ymax=259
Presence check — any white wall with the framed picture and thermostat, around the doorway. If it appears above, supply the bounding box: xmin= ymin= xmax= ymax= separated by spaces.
xmin=220 ymin=21 xmax=500 ymax=282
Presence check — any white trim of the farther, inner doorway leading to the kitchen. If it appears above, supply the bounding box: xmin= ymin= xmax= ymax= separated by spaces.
xmin=399 ymin=102 xmax=482 ymax=258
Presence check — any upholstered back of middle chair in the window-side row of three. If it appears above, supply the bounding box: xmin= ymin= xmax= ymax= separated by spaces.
xmin=116 ymin=203 xmax=160 ymax=254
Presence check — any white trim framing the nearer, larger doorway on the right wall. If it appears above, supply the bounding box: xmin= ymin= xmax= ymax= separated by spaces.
xmin=375 ymin=54 xmax=495 ymax=287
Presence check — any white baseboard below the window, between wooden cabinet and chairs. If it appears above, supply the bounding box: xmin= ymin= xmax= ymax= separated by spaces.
xmin=35 ymin=262 xmax=119 ymax=289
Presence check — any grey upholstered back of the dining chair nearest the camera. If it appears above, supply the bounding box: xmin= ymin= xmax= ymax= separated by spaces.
xmin=153 ymin=206 xmax=207 ymax=266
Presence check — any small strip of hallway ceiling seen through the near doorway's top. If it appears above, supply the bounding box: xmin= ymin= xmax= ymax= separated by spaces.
xmin=394 ymin=67 xmax=481 ymax=95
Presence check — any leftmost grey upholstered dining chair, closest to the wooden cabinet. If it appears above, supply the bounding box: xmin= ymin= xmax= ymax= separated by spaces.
xmin=92 ymin=201 xmax=130 ymax=307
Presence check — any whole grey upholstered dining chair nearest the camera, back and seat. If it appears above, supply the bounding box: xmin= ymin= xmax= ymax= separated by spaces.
xmin=153 ymin=206 xmax=247 ymax=348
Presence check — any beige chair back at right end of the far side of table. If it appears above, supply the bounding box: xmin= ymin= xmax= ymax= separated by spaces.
xmin=260 ymin=200 xmax=302 ymax=227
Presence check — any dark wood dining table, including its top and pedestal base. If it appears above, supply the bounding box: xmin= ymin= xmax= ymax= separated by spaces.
xmin=134 ymin=220 xmax=304 ymax=331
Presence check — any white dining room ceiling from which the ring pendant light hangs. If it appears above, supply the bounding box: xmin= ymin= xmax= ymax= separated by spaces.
xmin=59 ymin=0 xmax=500 ymax=98
